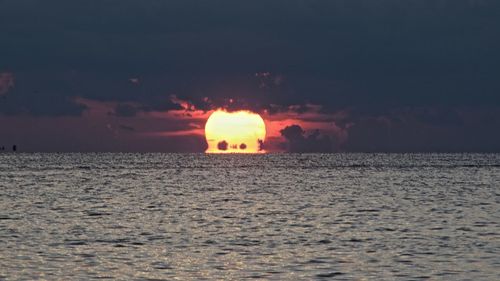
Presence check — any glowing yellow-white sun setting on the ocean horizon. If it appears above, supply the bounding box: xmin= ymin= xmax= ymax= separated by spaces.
xmin=205 ymin=110 xmax=266 ymax=153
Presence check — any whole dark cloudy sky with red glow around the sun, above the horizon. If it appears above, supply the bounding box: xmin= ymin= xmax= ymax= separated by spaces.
xmin=0 ymin=0 xmax=500 ymax=152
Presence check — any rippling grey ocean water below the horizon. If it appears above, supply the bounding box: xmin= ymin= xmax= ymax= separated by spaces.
xmin=0 ymin=154 xmax=500 ymax=280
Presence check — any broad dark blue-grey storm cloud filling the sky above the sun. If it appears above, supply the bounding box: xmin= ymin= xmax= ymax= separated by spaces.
xmin=0 ymin=0 xmax=500 ymax=112
